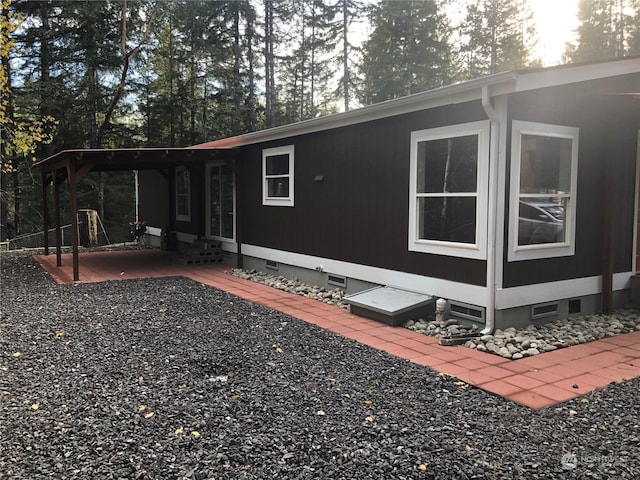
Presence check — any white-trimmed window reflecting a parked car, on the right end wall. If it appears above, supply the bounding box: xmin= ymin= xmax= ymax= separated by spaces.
xmin=508 ymin=120 xmax=579 ymax=261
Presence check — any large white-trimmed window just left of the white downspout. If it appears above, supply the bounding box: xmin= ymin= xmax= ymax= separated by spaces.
xmin=409 ymin=121 xmax=490 ymax=259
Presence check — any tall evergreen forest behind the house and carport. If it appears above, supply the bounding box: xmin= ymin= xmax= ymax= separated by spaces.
xmin=0 ymin=0 xmax=640 ymax=246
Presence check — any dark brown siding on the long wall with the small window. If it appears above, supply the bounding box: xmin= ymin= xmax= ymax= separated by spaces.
xmin=240 ymin=102 xmax=486 ymax=285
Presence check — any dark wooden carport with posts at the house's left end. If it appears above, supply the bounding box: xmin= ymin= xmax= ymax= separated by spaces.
xmin=36 ymin=148 xmax=236 ymax=281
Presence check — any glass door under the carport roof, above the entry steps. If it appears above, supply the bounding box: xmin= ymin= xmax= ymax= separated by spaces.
xmin=207 ymin=164 xmax=236 ymax=240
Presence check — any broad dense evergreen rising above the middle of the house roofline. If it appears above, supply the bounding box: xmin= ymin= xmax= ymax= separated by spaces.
xmin=360 ymin=0 xmax=451 ymax=104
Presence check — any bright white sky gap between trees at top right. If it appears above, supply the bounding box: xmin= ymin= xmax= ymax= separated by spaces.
xmin=529 ymin=0 xmax=578 ymax=66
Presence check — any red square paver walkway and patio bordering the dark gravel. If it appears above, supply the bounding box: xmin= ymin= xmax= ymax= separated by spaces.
xmin=35 ymin=249 xmax=640 ymax=409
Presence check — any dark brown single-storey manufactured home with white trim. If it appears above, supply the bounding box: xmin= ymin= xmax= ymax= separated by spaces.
xmin=127 ymin=58 xmax=640 ymax=331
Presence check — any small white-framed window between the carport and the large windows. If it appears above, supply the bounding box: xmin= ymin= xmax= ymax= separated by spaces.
xmin=262 ymin=145 xmax=294 ymax=207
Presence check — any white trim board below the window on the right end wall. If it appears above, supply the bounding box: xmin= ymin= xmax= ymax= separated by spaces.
xmin=496 ymin=272 xmax=633 ymax=310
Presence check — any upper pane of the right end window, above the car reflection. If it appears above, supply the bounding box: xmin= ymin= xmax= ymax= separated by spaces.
xmin=520 ymin=135 xmax=573 ymax=193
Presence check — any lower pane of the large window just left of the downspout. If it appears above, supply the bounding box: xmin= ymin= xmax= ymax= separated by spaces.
xmin=418 ymin=197 xmax=476 ymax=244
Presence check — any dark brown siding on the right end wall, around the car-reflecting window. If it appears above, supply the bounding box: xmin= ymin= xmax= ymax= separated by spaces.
xmin=503 ymin=75 xmax=640 ymax=287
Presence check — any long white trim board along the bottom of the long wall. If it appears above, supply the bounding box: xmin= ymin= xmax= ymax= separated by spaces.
xmin=242 ymin=244 xmax=487 ymax=307
